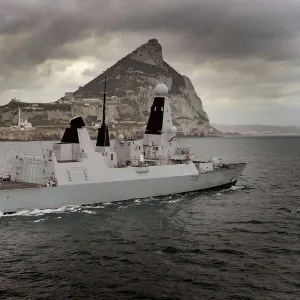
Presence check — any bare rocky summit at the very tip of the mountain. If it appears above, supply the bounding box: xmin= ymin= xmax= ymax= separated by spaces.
xmin=130 ymin=38 xmax=164 ymax=68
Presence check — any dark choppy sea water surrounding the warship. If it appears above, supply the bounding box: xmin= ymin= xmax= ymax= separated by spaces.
xmin=0 ymin=137 xmax=300 ymax=300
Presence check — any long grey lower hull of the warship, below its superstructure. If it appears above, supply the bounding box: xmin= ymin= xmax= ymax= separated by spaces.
xmin=0 ymin=163 xmax=246 ymax=213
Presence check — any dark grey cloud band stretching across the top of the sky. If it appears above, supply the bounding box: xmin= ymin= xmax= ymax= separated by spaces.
xmin=0 ymin=0 xmax=300 ymax=67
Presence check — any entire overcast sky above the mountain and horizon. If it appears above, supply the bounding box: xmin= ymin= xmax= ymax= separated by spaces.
xmin=0 ymin=0 xmax=300 ymax=125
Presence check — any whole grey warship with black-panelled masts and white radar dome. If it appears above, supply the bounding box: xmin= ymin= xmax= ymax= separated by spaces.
xmin=0 ymin=79 xmax=246 ymax=214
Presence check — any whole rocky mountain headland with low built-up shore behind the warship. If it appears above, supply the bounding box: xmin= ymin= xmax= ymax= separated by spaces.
xmin=0 ymin=39 xmax=218 ymax=140
